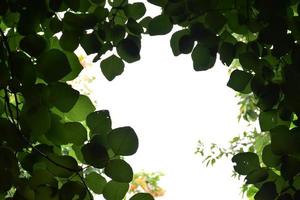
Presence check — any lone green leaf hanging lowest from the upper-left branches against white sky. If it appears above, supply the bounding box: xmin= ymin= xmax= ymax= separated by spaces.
xmin=100 ymin=55 xmax=124 ymax=81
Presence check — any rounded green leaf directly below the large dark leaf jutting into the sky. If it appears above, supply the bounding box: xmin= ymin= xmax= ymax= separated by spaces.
xmin=104 ymin=159 xmax=133 ymax=183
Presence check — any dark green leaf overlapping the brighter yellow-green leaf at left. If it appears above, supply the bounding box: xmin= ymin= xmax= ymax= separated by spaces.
xmin=49 ymin=82 xmax=79 ymax=112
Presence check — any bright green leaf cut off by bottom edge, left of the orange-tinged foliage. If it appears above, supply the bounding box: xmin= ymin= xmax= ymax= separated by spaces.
xmin=103 ymin=180 xmax=129 ymax=200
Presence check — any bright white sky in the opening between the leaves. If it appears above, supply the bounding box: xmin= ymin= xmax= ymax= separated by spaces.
xmin=77 ymin=32 xmax=245 ymax=200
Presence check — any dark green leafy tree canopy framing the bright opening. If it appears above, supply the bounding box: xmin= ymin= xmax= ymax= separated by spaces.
xmin=0 ymin=0 xmax=300 ymax=200
